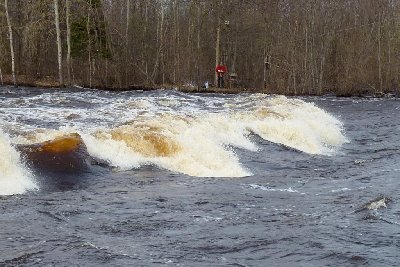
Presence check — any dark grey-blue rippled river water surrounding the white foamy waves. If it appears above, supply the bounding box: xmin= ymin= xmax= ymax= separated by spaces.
xmin=0 ymin=88 xmax=400 ymax=266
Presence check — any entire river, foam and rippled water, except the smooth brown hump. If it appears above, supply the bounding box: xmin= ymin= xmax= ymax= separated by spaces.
xmin=0 ymin=87 xmax=400 ymax=266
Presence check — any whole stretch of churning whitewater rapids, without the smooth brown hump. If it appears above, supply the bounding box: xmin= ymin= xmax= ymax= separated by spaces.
xmin=0 ymin=91 xmax=347 ymax=194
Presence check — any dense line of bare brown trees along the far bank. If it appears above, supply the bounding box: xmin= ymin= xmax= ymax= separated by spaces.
xmin=0 ymin=0 xmax=400 ymax=94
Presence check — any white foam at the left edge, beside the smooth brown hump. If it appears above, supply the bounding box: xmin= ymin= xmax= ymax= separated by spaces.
xmin=0 ymin=131 xmax=37 ymax=195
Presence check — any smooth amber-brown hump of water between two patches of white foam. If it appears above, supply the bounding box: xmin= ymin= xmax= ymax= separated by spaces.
xmin=18 ymin=133 xmax=88 ymax=174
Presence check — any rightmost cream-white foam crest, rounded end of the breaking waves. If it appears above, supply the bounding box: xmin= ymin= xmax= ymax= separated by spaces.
xmin=245 ymin=97 xmax=347 ymax=155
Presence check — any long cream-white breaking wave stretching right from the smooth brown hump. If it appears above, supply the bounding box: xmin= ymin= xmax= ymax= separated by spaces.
xmin=7 ymin=95 xmax=346 ymax=180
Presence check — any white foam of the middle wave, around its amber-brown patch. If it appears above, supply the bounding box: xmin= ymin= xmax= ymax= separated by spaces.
xmin=82 ymin=117 xmax=251 ymax=177
